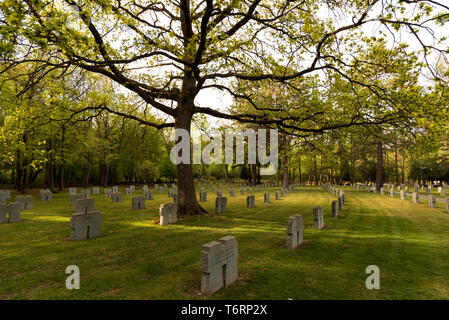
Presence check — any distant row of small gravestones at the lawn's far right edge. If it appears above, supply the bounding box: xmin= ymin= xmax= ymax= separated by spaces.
xmin=352 ymin=184 xmax=449 ymax=213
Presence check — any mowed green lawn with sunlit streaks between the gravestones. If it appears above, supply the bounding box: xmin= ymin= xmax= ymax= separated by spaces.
xmin=0 ymin=187 xmax=449 ymax=299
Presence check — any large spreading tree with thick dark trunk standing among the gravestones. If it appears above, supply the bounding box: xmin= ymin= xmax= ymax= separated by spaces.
xmin=0 ymin=0 xmax=449 ymax=214
